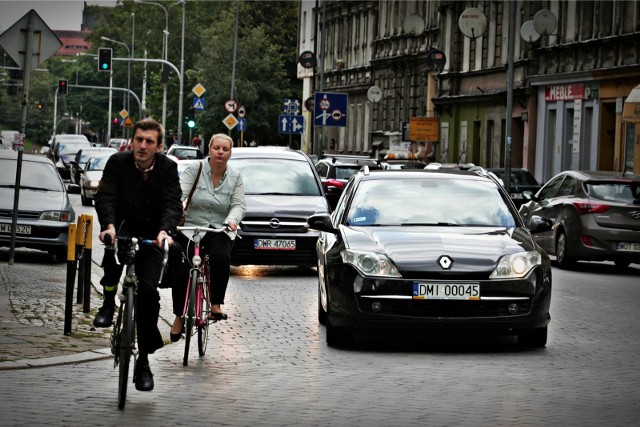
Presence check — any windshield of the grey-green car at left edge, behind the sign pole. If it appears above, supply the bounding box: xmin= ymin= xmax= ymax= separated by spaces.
xmin=0 ymin=159 xmax=64 ymax=192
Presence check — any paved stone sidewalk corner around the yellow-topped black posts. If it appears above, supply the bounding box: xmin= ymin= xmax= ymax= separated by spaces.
xmin=0 ymin=252 xmax=171 ymax=370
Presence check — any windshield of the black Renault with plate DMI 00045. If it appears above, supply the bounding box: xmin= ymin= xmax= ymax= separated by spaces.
xmin=347 ymin=177 xmax=516 ymax=227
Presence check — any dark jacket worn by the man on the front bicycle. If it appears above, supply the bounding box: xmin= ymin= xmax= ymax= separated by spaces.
xmin=96 ymin=151 xmax=182 ymax=239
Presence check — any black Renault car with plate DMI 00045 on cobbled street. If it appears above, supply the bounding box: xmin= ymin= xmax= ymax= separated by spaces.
xmin=309 ymin=168 xmax=551 ymax=347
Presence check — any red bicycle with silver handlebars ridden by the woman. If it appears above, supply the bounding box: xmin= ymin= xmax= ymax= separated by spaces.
xmin=177 ymin=226 xmax=235 ymax=366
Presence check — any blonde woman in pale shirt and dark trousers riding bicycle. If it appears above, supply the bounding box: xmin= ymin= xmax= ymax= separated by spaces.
xmin=170 ymin=134 xmax=246 ymax=342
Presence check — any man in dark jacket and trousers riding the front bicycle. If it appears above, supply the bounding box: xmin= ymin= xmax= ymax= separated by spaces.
xmin=94 ymin=118 xmax=182 ymax=391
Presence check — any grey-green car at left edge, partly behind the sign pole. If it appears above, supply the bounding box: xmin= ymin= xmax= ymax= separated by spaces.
xmin=0 ymin=150 xmax=80 ymax=261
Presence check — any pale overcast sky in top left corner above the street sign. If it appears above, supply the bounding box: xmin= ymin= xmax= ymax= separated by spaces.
xmin=0 ymin=0 xmax=115 ymax=34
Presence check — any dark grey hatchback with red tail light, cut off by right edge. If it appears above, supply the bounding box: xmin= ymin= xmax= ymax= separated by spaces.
xmin=520 ymin=171 xmax=640 ymax=268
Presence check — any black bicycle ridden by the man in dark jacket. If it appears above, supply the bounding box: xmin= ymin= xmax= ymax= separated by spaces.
xmin=110 ymin=235 xmax=169 ymax=409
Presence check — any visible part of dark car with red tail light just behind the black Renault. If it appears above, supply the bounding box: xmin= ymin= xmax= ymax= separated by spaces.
xmin=315 ymin=156 xmax=382 ymax=209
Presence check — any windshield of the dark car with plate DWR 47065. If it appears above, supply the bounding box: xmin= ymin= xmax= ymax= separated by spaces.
xmin=229 ymin=158 xmax=321 ymax=196
